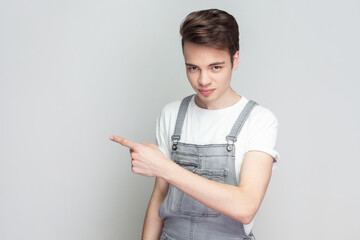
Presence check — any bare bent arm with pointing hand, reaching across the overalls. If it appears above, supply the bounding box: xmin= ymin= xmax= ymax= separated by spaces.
xmin=109 ymin=137 xmax=273 ymax=224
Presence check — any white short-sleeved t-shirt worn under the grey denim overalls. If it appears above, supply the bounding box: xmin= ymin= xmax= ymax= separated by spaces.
xmin=156 ymin=96 xmax=280 ymax=234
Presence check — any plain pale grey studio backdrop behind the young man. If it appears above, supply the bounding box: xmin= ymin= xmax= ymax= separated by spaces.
xmin=0 ymin=0 xmax=360 ymax=240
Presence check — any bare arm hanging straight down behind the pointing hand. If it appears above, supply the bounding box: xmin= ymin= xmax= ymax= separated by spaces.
xmin=142 ymin=178 xmax=169 ymax=240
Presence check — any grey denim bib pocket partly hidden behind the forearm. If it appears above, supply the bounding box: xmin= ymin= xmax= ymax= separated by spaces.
xmin=169 ymin=167 xmax=227 ymax=217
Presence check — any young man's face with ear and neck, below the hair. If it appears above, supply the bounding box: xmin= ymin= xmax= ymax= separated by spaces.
xmin=184 ymin=41 xmax=239 ymax=109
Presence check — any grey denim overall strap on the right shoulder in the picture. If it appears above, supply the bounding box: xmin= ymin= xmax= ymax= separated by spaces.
xmin=226 ymin=100 xmax=258 ymax=151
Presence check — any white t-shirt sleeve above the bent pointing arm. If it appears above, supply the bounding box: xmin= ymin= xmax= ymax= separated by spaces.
xmin=245 ymin=106 xmax=280 ymax=169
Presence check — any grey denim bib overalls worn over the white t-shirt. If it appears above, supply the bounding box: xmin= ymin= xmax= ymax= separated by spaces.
xmin=159 ymin=95 xmax=257 ymax=240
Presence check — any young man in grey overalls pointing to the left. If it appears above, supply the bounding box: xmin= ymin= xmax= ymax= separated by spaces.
xmin=111 ymin=9 xmax=279 ymax=240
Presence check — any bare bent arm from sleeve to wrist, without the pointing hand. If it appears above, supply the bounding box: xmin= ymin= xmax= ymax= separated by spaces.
xmin=163 ymin=151 xmax=273 ymax=224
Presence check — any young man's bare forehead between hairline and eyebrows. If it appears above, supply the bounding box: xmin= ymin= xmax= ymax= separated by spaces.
xmin=184 ymin=41 xmax=230 ymax=66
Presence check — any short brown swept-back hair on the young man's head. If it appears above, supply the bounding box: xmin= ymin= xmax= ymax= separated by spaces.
xmin=180 ymin=9 xmax=239 ymax=63
